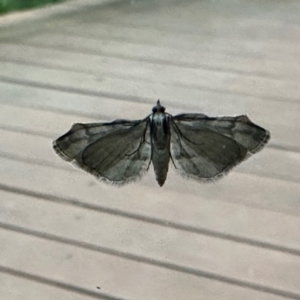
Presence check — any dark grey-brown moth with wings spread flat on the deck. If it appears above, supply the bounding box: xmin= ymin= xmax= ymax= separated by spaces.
xmin=53 ymin=100 xmax=270 ymax=186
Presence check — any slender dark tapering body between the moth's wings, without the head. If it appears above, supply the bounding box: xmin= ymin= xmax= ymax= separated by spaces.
xmin=150 ymin=111 xmax=171 ymax=186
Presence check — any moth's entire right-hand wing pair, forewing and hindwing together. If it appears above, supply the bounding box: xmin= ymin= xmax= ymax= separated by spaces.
xmin=171 ymin=114 xmax=270 ymax=182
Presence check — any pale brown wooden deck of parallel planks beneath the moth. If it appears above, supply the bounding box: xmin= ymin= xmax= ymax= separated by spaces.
xmin=0 ymin=0 xmax=300 ymax=300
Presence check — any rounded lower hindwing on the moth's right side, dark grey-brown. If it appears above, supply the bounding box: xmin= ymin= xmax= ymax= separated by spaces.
xmin=171 ymin=114 xmax=253 ymax=182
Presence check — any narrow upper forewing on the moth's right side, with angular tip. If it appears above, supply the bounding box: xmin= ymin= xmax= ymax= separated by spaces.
xmin=173 ymin=114 xmax=270 ymax=156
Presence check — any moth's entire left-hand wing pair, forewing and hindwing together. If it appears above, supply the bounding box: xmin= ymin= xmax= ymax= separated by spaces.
xmin=53 ymin=118 xmax=151 ymax=185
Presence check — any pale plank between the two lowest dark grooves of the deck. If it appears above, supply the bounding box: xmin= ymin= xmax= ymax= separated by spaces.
xmin=0 ymin=229 xmax=292 ymax=300
